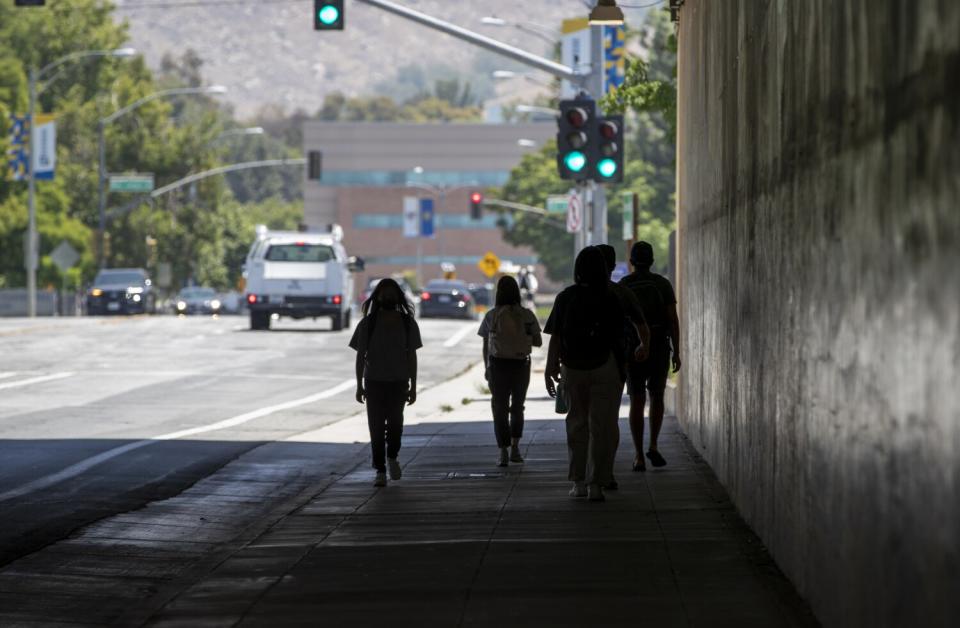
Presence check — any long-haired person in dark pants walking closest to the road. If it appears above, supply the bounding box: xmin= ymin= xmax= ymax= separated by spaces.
xmin=350 ymin=279 xmax=423 ymax=486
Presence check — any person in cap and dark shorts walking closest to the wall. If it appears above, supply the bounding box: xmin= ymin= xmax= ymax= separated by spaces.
xmin=620 ymin=242 xmax=681 ymax=471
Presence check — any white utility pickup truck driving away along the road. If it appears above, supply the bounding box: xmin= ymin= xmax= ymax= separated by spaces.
xmin=245 ymin=226 xmax=363 ymax=331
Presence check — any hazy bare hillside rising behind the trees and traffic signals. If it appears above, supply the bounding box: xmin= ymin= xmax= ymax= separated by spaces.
xmin=117 ymin=0 xmax=584 ymax=116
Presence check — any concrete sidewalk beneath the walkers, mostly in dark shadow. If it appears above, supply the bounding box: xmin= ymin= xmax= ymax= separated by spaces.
xmin=126 ymin=369 xmax=816 ymax=628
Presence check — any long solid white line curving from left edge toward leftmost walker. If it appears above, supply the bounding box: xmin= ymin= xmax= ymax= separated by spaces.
xmin=0 ymin=379 xmax=356 ymax=502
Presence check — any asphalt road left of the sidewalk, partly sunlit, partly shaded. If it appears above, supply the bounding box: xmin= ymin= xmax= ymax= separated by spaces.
xmin=0 ymin=316 xmax=480 ymax=565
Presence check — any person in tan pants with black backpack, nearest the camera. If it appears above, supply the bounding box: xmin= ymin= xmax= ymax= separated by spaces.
xmin=544 ymin=247 xmax=625 ymax=501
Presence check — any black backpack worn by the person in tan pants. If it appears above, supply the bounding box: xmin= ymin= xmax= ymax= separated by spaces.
xmin=562 ymin=286 xmax=623 ymax=370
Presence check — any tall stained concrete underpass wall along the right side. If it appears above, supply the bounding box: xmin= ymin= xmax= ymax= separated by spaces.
xmin=678 ymin=0 xmax=960 ymax=627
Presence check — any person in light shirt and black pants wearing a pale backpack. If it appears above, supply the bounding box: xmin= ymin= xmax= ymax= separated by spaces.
xmin=477 ymin=276 xmax=543 ymax=467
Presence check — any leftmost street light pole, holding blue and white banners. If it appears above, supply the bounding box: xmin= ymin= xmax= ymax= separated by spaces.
xmin=25 ymin=48 xmax=137 ymax=318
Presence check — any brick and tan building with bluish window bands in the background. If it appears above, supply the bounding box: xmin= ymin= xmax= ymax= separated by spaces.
xmin=304 ymin=122 xmax=556 ymax=288
